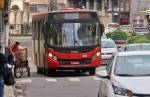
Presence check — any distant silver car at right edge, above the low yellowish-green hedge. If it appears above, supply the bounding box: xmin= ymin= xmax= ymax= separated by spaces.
xmin=132 ymin=27 xmax=150 ymax=35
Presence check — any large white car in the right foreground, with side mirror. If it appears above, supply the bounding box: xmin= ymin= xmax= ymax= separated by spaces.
xmin=96 ymin=51 xmax=150 ymax=97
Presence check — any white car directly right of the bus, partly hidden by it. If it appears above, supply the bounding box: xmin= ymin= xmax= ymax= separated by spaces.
xmin=101 ymin=38 xmax=117 ymax=64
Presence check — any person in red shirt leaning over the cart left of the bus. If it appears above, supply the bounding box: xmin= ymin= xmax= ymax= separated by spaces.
xmin=8 ymin=42 xmax=20 ymax=65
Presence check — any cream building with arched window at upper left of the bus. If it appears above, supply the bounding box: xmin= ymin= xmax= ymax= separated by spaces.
xmin=9 ymin=0 xmax=29 ymax=35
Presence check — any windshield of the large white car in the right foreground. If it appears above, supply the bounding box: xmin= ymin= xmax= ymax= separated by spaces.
xmin=115 ymin=55 xmax=150 ymax=76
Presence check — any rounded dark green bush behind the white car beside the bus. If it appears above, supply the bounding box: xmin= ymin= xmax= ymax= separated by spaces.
xmin=106 ymin=29 xmax=128 ymax=40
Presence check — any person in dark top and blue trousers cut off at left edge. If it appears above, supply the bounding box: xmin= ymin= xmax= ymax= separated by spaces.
xmin=0 ymin=45 xmax=7 ymax=97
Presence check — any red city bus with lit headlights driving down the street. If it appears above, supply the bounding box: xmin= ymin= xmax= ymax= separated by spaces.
xmin=32 ymin=8 xmax=104 ymax=75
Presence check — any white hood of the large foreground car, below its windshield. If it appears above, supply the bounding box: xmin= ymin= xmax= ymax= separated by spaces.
xmin=112 ymin=76 xmax=150 ymax=94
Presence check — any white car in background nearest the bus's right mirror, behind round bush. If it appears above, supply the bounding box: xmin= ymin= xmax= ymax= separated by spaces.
xmin=105 ymin=23 xmax=119 ymax=33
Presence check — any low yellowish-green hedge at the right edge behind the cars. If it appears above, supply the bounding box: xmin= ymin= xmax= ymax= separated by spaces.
xmin=127 ymin=36 xmax=150 ymax=44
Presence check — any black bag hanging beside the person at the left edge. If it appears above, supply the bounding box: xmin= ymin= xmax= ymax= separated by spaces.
xmin=3 ymin=64 xmax=15 ymax=85
